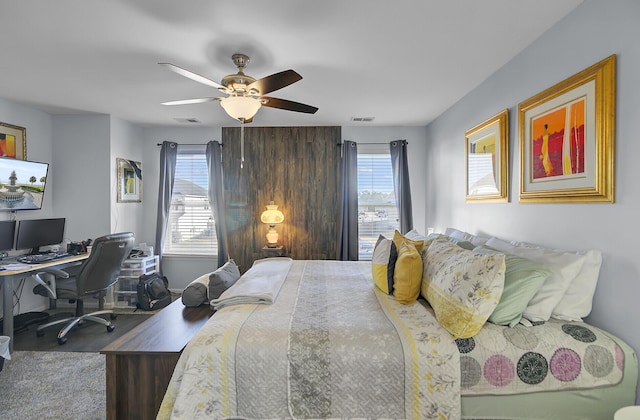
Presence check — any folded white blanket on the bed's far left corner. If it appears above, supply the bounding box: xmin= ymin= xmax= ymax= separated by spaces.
xmin=211 ymin=257 xmax=293 ymax=310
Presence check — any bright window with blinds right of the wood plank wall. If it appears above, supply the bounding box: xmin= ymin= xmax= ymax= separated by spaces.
xmin=358 ymin=144 xmax=398 ymax=260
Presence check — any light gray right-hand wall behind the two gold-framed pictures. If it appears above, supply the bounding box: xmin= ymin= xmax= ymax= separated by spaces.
xmin=426 ymin=0 xmax=640 ymax=400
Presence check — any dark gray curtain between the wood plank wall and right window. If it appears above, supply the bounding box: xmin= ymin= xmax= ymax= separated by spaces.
xmin=337 ymin=141 xmax=358 ymax=261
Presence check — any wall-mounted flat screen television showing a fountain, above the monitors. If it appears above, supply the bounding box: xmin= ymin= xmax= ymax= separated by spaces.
xmin=0 ymin=158 xmax=49 ymax=211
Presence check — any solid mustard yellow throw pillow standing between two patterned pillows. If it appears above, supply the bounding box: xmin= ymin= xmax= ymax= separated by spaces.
xmin=393 ymin=240 xmax=422 ymax=304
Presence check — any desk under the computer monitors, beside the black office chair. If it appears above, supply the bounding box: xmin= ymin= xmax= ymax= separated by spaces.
xmin=0 ymin=253 xmax=89 ymax=350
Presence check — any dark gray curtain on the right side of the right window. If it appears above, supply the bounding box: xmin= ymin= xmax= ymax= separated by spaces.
xmin=389 ymin=140 xmax=413 ymax=233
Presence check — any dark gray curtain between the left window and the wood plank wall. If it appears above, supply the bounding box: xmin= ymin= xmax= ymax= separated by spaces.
xmin=206 ymin=141 xmax=229 ymax=267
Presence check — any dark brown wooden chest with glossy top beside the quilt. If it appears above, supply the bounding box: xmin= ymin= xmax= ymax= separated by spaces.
xmin=100 ymin=299 xmax=213 ymax=419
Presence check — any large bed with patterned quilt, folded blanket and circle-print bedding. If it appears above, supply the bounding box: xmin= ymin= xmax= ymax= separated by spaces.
xmin=158 ymin=230 xmax=638 ymax=419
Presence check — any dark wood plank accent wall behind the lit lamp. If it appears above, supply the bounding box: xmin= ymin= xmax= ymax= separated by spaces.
xmin=222 ymin=127 xmax=341 ymax=272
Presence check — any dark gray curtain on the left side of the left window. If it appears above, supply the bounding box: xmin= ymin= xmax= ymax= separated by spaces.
xmin=155 ymin=141 xmax=178 ymax=274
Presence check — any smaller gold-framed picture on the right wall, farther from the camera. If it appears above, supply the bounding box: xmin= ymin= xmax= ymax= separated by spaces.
xmin=464 ymin=109 xmax=509 ymax=203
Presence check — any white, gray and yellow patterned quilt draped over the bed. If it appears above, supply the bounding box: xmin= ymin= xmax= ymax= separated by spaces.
xmin=158 ymin=261 xmax=461 ymax=419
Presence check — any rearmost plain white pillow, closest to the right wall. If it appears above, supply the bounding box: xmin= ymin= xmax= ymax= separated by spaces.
xmin=511 ymin=241 xmax=602 ymax=321
